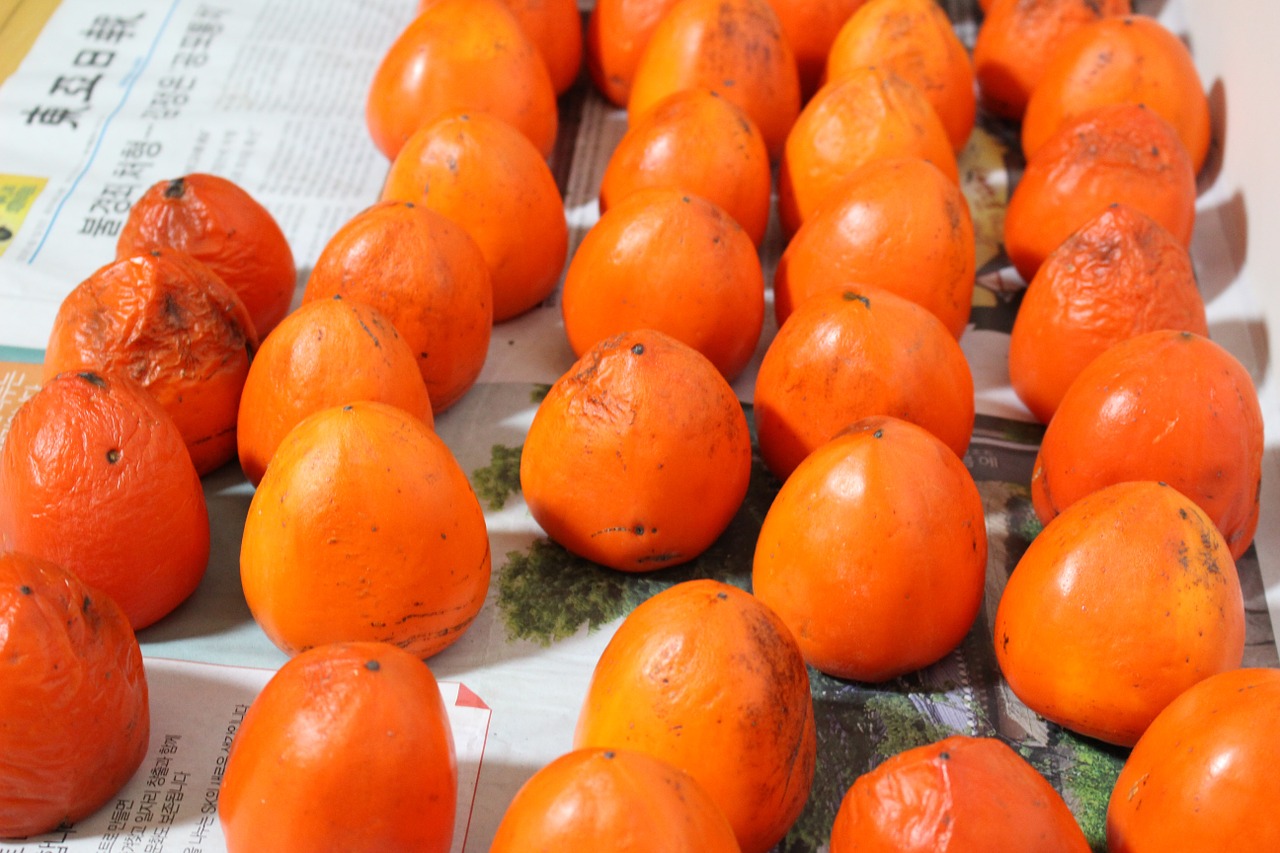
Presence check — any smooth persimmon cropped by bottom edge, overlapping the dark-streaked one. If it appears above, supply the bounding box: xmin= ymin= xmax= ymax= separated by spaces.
xmin=489 ymin=747 xmax=740 ymax=853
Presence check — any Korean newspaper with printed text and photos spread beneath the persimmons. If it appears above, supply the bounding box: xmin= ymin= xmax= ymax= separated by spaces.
xmin=0 ymin=0 xmax=1280 ymax=853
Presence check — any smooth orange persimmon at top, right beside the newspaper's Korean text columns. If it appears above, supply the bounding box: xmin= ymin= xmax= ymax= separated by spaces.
xmin=365 ymin=0 xmax=559 ymax=160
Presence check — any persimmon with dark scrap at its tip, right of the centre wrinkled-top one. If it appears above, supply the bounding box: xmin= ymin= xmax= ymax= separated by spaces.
xmin=754 ymin=288 xmax=974 ymax=480
